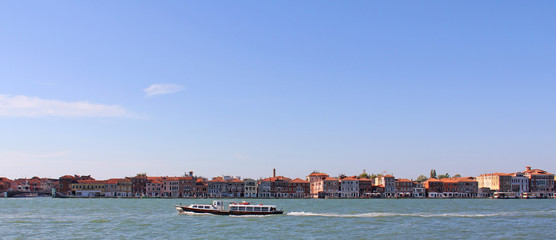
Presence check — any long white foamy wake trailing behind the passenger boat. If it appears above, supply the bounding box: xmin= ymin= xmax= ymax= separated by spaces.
xmin=287 ymin=211 xmax=556 ymax=218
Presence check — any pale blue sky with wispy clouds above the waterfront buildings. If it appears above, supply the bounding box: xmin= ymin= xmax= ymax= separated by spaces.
xmin=0 ymin=1 xmax=556 ymax=179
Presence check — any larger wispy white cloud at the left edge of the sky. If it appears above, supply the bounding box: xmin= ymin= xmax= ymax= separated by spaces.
xmin=0 ymin=95 xmax=133 ymax=118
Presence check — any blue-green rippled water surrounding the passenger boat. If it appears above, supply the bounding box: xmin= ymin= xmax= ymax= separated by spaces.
xmin=0 ymin=198 xmax=556 ymax=239
